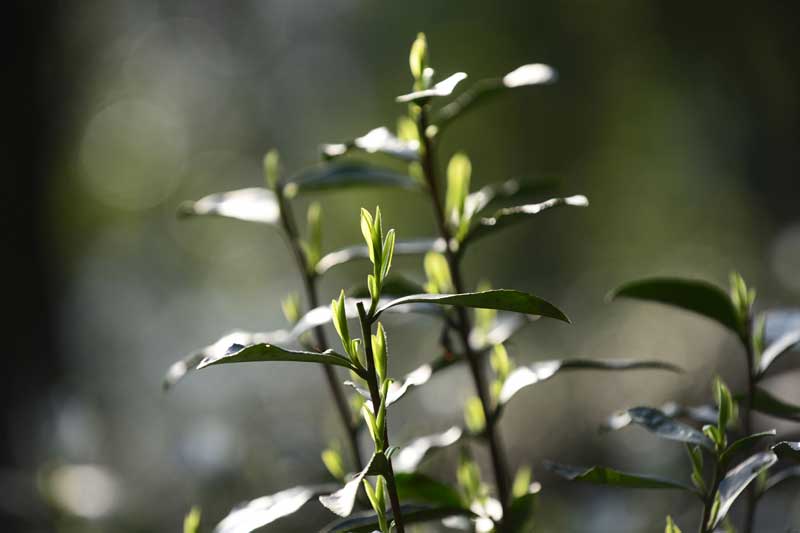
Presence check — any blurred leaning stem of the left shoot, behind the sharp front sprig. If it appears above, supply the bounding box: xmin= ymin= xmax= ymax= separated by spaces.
xmin=276 ymin=188 xmax=364 ymax=472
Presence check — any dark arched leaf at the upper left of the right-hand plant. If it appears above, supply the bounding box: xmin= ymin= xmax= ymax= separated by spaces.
xmin=610 ymin=278 xmax=741 ymax=335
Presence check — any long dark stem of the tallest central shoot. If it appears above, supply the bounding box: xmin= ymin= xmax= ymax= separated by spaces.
xmin=417 ymin=107 xmax=510 ymax=516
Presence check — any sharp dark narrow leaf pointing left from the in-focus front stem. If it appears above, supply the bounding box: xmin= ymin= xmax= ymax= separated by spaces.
xmin=194 ymin=343 xmax=362 ymax=373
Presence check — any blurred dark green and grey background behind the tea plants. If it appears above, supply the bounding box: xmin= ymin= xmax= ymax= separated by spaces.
xmin=6 ymin=0 xmax=800 ymax=533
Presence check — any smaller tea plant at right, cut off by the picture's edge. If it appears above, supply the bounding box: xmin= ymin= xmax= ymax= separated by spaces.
xmin=549 ymin=273 xmax=800 ymax=533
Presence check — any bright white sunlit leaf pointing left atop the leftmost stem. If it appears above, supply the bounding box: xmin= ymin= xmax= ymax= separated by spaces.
xmin=178 ymin=187 xmax=280 ymax=225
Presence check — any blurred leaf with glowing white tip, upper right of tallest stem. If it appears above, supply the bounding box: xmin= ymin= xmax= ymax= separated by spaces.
xmin=434 ymin=63 xmax=557 ymax=130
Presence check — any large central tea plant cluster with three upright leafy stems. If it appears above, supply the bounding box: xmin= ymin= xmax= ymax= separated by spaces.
xmin=159 ymin=35 xmax=796 ymax=533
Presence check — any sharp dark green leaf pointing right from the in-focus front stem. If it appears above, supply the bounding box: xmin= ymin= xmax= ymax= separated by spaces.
xmin=376 ymin=289 xmax=569 ymax=323
